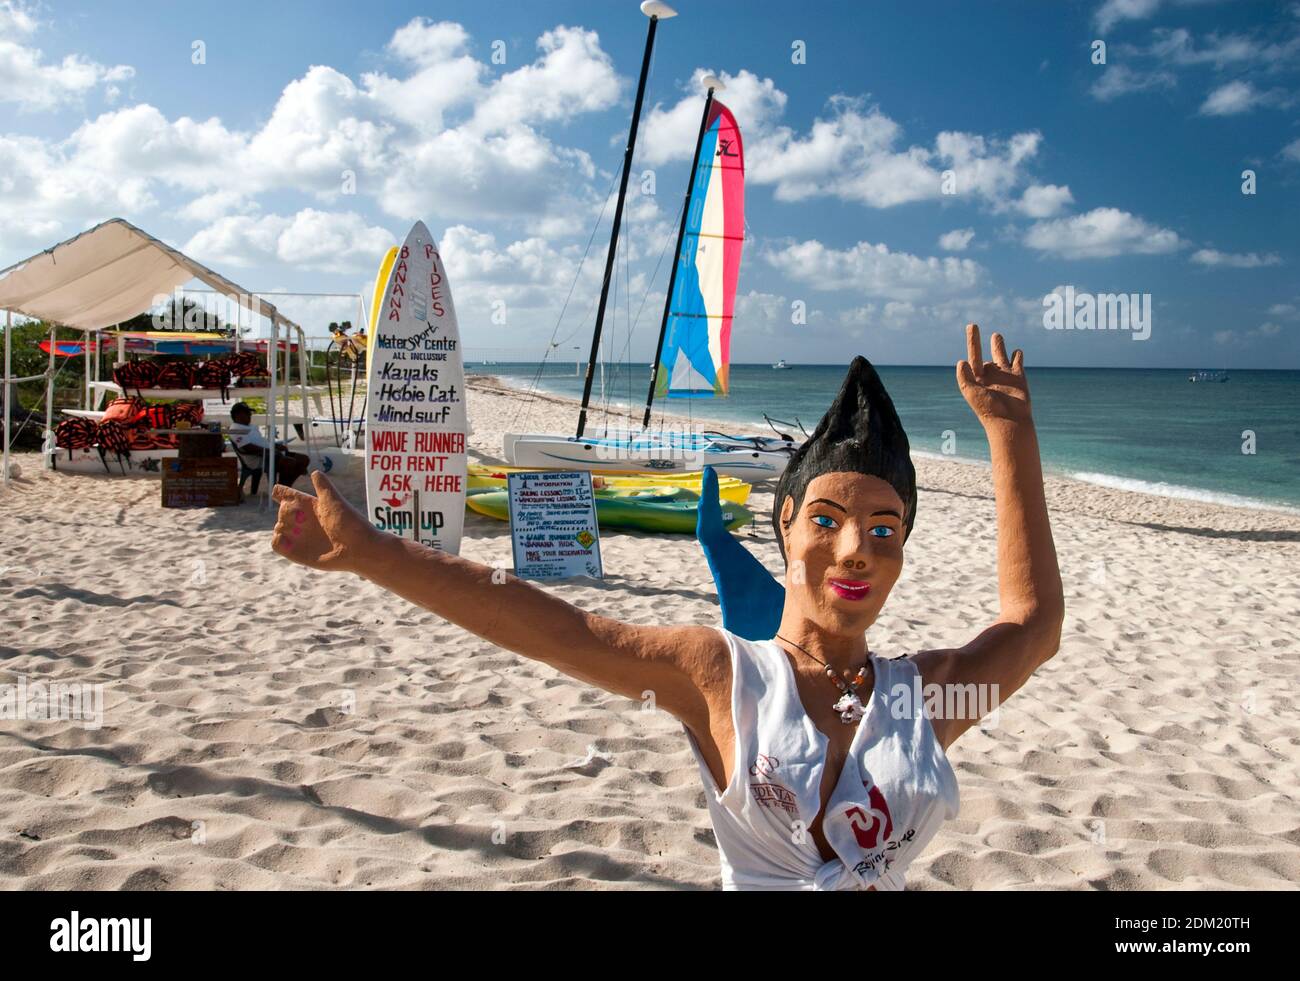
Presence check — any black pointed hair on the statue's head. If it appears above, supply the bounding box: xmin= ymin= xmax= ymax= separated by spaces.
xmin=772 ymin=355 xmax=917 ymax=560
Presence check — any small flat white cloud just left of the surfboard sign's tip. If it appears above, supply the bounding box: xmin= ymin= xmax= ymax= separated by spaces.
xmin=181 ymin=208 xmax=397 ymax=273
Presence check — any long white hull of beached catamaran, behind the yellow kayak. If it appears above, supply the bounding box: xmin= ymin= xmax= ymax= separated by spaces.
xmin=503 ymin=430 xmax=798 ymax=482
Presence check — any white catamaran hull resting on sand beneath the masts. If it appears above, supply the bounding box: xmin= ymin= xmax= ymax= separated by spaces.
xmin=504 ymin=433 xmax=790 ymax=482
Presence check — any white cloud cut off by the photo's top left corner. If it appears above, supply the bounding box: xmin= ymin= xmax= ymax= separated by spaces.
xmin=0 ymin=0 xmax=135 ymax=112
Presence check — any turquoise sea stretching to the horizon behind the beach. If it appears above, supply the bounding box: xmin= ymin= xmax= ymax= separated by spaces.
xmin=478 ymin=361 xmax=1300 ymax=508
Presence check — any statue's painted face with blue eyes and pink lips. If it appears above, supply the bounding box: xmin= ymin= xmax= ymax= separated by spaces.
xmin=781 ymin=473 xmax=905 ymax=635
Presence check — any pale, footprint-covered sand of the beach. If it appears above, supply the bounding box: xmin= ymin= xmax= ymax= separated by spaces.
xmin=0 ymin=379 xmax=1300 ymax=890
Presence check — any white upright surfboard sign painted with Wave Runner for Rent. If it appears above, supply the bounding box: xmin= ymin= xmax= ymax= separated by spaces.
xmin=365 ymin=222 xmax=468 ymax=555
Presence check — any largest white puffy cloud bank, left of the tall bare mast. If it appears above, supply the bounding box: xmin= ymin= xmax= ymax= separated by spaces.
xmin=0 ymin=19 xmax=620 ymax=250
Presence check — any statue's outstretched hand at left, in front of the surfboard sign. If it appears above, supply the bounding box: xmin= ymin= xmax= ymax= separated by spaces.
xmin=270 ymin=470 xmax=382 ymax=572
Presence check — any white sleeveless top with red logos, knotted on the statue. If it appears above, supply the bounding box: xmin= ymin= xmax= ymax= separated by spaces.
xmin=686 ymin=628 xmax=958 ymax=890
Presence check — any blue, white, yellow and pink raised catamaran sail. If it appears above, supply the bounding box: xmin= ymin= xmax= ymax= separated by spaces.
xmin=654 ymin=100 xmax=745 ymax=399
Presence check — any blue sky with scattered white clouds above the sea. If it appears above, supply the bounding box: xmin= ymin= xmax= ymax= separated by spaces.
xmin=0 ymin=0 xmax=1300 ymax=368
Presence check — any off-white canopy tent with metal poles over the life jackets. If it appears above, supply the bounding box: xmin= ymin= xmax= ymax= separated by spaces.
xmin=0 ymin=218 xmax=311 ymax=498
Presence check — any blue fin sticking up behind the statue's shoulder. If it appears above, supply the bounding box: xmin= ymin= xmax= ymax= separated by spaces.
xmin=696 ymin=466 xmax=785 ymax=641
